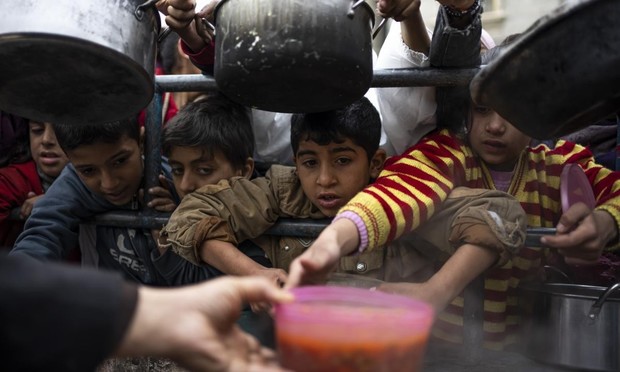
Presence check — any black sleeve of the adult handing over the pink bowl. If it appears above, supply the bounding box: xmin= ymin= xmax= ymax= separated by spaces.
xmin=0 ymin=256 xmax=137 ymax=371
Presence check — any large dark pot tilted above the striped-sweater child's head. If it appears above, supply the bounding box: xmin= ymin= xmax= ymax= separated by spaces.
xmin=471 ymin=0 xmax=620 ymax=139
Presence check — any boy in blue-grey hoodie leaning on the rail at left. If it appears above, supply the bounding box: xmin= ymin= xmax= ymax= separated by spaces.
xmin=11 ymin=119 xmax=176 ymax=285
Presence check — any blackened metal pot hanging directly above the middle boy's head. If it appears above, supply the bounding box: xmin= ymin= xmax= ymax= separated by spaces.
xmin=214 ymin=0 xmax=375 ymax=112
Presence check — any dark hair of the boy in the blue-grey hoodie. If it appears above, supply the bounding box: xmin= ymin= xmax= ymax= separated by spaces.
xmin=52 ymin=117 xmax=140 ymax=152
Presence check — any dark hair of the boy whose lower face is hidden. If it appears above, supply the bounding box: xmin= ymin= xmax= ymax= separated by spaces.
xmin=162 ymin=93 xmax=254 ymax=169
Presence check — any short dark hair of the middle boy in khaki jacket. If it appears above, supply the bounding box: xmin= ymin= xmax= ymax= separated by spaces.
xmin=291 ymin=97 xmax=381 ymax=160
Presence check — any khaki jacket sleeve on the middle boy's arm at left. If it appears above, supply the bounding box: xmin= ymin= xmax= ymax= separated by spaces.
xmin=162 ymin=166 xmax=320 ymax=264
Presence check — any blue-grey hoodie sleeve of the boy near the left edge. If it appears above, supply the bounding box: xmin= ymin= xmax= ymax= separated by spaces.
xmin=11 ymin=165 xmax=110 ymax=260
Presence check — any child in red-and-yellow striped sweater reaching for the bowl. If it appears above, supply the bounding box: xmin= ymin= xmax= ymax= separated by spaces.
xmin=287 ymin=42 xmax=620 ymax=349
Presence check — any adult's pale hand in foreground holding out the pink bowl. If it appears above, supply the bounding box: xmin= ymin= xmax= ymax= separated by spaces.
xmin=117 ymin=277 xmax=292 ymax=372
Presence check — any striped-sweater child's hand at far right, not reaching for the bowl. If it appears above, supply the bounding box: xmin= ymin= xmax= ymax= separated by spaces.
xmin=541 ymin=203 xmax=618 ymax=264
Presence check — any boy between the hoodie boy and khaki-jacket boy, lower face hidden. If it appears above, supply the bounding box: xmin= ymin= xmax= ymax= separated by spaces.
xmin=154 ymin=93 xmax=284 ymax=284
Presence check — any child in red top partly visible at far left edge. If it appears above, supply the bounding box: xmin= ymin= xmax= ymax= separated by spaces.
xmin=0 ymin=120 xmax=68 ymax=249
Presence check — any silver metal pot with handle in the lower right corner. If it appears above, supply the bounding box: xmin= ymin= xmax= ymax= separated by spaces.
xmin=521 ymin=283 xmax=620 ymax=371
